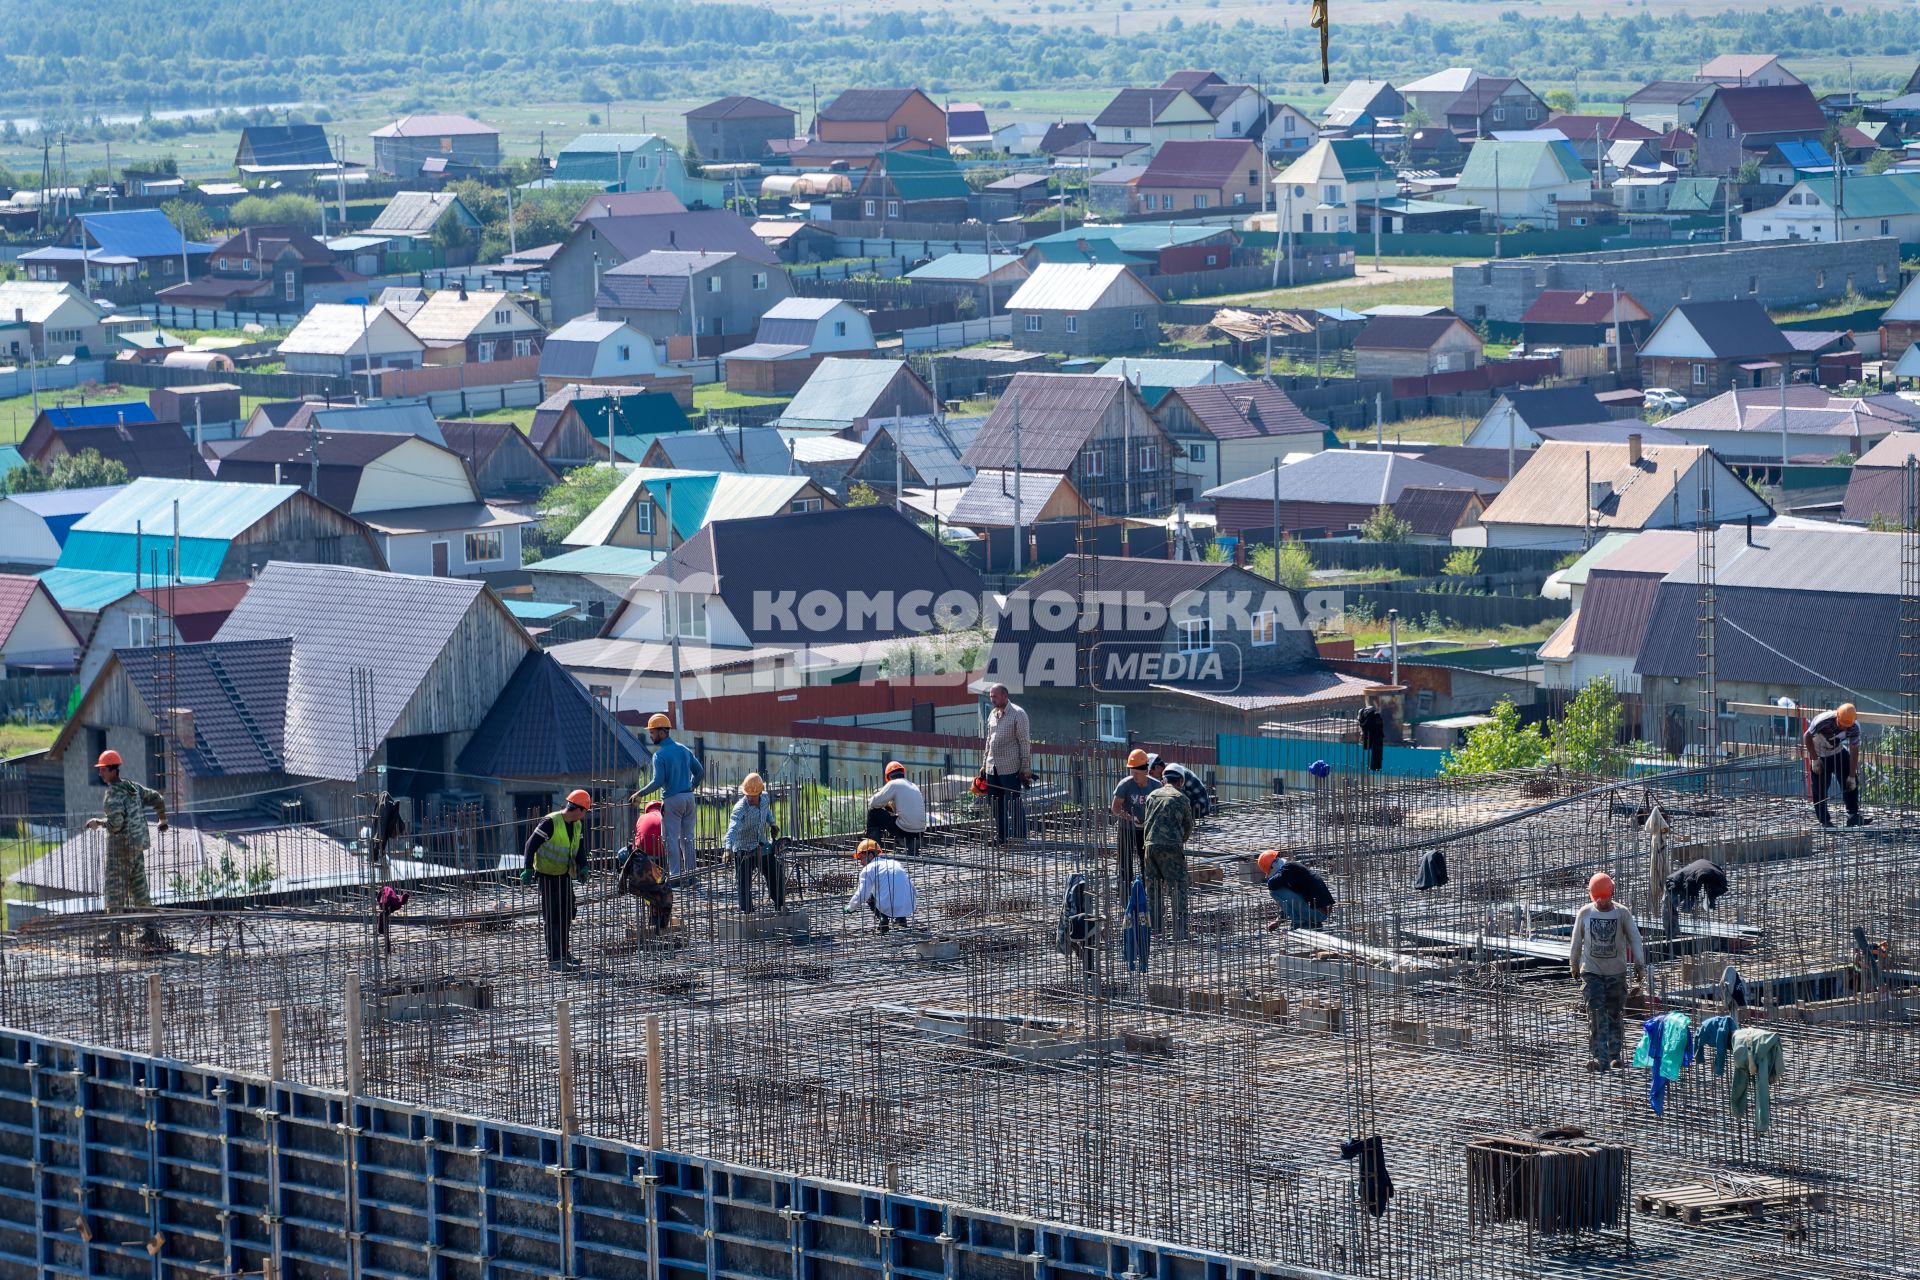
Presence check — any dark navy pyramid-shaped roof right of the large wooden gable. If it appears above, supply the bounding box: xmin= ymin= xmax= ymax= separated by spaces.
xmin=453 ymin=649 xmax=647 ymax=779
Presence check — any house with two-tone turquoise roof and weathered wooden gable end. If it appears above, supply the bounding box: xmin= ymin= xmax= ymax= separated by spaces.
xmin=40 ymin=478 xmax=386 ymax=614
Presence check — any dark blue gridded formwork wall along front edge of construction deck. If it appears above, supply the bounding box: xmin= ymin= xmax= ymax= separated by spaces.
xmin=0 ymin=1032 xmax=1321 ymax=1280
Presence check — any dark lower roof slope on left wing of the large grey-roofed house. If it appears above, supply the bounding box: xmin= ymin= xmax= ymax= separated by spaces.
xmin=113 ymin=637 xmax=294 ymax=777
